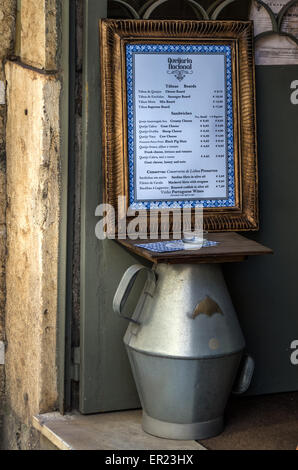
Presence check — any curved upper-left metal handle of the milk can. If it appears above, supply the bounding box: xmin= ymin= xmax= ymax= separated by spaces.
xmin=113 ymin=264 xmax=156 ymax=324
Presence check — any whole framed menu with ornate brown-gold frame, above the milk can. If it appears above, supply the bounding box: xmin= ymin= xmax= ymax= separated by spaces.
xmin=100 ymin=20 xmax=258 ymax=231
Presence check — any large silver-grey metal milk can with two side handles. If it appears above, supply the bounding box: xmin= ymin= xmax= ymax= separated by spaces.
xmin=113 ymin=264 xmax=253 ymax=439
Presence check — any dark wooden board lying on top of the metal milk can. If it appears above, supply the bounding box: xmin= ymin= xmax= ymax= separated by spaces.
xmin=117 ymin=232 xmax=273 ymax=264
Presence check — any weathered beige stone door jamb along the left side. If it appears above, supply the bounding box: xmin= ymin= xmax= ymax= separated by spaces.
xmin=0 ymin=0 xmax=61 ymax=449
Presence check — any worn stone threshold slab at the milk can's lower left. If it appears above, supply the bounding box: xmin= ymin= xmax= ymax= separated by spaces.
xmin=33 ymin=410 xmax=206 ymax=450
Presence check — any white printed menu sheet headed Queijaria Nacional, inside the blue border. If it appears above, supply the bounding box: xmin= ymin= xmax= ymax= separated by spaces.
xmin=130 ymin=49 xmax=229 ymax=202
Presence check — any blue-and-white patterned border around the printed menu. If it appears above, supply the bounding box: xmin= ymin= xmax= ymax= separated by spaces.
xmin=126 ymin=44 xmax=235 ymax=210
